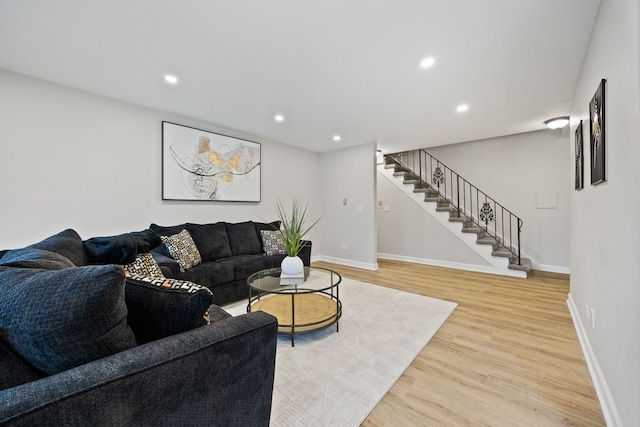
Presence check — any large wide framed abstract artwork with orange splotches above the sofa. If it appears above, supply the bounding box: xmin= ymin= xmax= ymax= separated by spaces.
xmin=162 ymin=121 xmax=261 ymax=202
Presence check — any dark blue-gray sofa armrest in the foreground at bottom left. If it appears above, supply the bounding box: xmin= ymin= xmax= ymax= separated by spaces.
xmin=0 ymin=312 xmax=278 ymax=426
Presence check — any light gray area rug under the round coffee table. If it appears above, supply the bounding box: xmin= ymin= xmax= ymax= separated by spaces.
xmin=224 ymin=278 xmax=457 ymax=427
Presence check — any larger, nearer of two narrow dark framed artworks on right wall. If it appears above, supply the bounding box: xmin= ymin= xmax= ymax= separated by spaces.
xmin=589 ymin=79 xmax=606 ymax=185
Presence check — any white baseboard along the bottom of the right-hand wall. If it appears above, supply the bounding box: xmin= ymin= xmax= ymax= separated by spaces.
xmin=567 ymin=294 xmax=622 ymax=427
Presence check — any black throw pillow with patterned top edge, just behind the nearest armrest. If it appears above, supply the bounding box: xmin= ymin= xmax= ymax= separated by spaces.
xmin=125 ymin=273 xmax=213 ymax=344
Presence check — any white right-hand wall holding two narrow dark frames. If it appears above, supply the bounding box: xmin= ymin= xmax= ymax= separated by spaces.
xmin=567 ymin=0 xmax=640 ymax=426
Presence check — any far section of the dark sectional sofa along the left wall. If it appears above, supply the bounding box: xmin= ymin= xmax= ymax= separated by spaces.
xmin=149 ymin=221 xmax=311 ymax=305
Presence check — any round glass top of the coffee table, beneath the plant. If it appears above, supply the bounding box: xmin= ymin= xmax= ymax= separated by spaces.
xmin=247 ymin=267 xmax=342 ymax=294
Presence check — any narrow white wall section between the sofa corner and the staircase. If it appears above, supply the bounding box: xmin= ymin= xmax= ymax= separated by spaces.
xmin=321 ymin=143 xmax=378 ymax=269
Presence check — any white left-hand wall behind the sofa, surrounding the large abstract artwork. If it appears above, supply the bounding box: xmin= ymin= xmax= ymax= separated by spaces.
xmin=0 ymin=70 xmax=323 ymax=251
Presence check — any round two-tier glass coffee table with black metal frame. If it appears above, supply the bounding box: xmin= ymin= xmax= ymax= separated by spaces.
xmin=247 ymin=267 xmax=342 ymax=347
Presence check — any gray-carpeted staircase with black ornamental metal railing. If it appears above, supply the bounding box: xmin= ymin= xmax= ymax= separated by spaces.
xmin=379 ymin=150 xmax=532 ymax=278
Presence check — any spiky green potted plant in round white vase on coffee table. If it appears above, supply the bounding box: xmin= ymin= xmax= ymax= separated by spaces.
xmin=276 ymin=199 xmax=322 ymax=275
